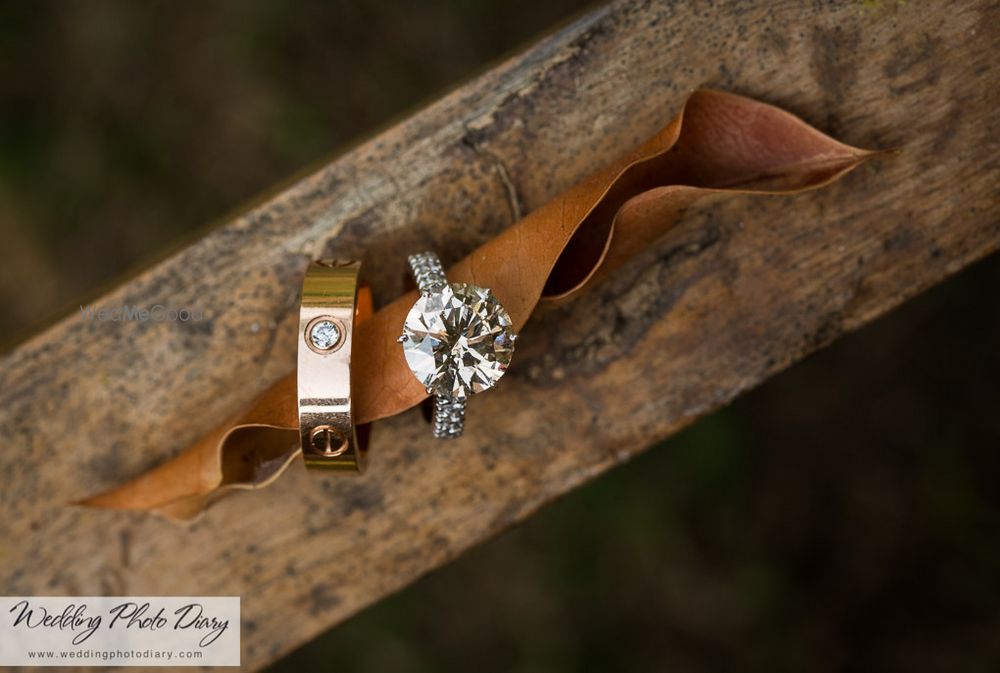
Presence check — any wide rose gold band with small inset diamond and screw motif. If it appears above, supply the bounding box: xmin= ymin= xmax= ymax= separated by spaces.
xmin=298 ymin=259 xmax=372 ymax=472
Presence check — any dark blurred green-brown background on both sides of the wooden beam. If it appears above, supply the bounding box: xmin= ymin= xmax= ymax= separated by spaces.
xmin=0 ymin=0 xmax=1000 ymax=673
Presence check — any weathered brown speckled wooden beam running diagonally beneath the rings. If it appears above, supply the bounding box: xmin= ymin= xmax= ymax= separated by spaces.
xmin=0 ymin=0 xmax=1000 ymax=668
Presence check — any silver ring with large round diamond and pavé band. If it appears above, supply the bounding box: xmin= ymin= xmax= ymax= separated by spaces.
xmin=399 ymin=252 xmax=517 ymax=438
